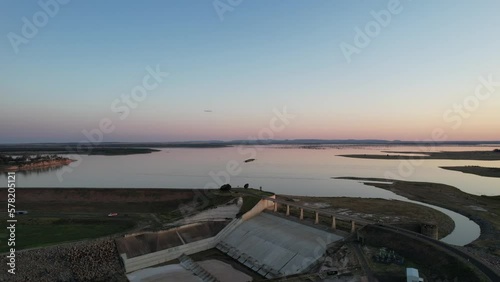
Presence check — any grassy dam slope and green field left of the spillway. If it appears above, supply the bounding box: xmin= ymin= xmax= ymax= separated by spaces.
xmin=0 ymin=188 xmax=239 ymax=252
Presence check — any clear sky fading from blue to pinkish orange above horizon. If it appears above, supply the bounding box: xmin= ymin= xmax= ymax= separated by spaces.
xmin=0 ymin=0 xmax=500 ymax=143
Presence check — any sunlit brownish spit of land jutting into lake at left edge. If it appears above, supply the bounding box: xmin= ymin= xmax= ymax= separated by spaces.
xmin=0 ymin=154 xmax=75 ymax=172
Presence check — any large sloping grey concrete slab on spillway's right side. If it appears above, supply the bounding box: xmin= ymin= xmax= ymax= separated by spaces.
xmin=217 ymin=213 xmax=342 ymax=278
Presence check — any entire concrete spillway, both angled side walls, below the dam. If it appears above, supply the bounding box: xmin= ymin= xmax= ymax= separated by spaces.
xmin=116 ymin=196 xmax=343 ymax=278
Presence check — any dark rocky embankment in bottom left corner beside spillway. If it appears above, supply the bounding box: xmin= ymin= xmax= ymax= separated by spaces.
xmin=0 ymin=239 xmax=128 ymax=282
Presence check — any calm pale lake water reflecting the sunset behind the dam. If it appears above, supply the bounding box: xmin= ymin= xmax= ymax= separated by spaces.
xmin=0 ymin=145 xmax=500 ymax=244
